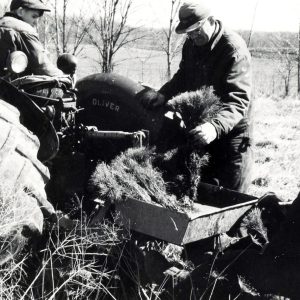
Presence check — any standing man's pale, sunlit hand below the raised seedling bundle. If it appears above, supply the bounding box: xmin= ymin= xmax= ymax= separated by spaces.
xmin=189 ymin=122 xmax=217 ymax=146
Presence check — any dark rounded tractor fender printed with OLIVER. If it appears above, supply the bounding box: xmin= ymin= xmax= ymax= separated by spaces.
xmin=76 ymin=73 xmax=164 ymax=144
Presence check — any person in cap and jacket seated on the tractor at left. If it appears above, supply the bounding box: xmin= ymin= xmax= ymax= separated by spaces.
xmin=0 ymin=0 xmax=62 ymax=76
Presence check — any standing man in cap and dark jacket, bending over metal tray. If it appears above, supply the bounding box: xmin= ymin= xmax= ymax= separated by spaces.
xmin=147 ymin=0 xmax=251 ymax=192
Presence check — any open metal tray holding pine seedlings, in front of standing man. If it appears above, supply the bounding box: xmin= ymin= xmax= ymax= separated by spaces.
xmin=116 ymin=183 xmax=258 ymax=245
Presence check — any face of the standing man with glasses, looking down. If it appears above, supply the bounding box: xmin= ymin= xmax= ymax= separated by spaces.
xmin=187 ymin=19 xmax=215 ymax=46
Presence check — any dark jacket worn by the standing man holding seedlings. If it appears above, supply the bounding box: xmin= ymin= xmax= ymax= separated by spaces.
xmin=160 ymin=21 xmax=251 ymax=138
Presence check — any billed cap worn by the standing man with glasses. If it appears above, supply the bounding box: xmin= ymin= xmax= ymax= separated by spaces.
xmin=175 ymin=0 xmax=211 ymax=34
